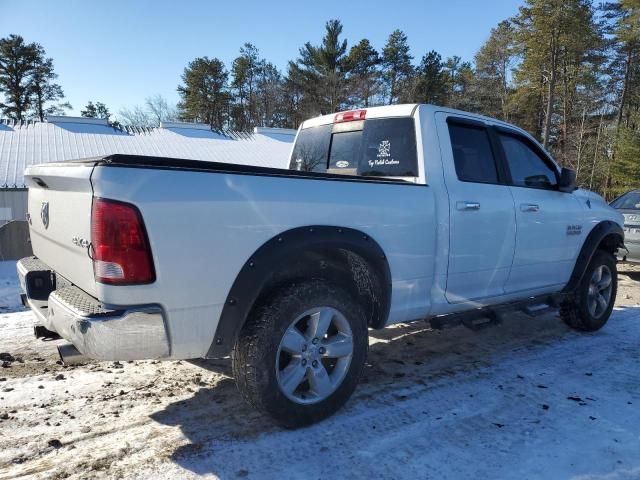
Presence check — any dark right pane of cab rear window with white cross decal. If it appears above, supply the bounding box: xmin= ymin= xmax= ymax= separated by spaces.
xmin=358 ymin=118 xmax=418 ymax=177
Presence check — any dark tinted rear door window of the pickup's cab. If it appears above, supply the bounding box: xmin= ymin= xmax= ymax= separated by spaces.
xmin=449 ymin=123 xmax=498 ymax=183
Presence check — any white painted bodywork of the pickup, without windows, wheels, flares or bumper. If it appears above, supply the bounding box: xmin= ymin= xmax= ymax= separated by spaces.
xmin=21 ymin=105 xmax=622 ymax=358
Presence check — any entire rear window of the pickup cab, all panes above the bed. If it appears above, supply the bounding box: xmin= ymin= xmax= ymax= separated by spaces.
xmin=289 ymin=118 xmax=418 ymax=177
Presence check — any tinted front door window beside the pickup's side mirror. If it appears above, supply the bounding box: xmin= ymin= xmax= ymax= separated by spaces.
xmin=500 ymin=133 xmax=558 ymax=188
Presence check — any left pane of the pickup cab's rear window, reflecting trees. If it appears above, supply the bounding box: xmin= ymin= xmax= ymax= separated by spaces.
xmin=289 ymin=125 xmax=332 ymax=172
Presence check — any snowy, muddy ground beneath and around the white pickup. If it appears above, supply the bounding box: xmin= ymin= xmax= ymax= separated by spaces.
xmin=0 ymin=264 xmax=640 ymax=479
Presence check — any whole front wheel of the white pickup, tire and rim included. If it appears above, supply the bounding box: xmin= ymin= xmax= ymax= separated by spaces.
xmin=560 ymin=250 xmax=618 ymax=332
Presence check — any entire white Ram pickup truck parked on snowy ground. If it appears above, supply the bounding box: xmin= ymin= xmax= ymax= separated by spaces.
xmin=18 ymin=105 xmax=624 ymax=427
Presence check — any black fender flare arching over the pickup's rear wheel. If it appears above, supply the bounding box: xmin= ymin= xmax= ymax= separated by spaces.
xmin=207 ymin=226 xmax=391 ymax=358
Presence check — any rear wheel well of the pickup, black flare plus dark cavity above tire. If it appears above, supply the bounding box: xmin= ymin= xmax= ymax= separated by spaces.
xmin=207 ymin=226 xmax=391 ymax=357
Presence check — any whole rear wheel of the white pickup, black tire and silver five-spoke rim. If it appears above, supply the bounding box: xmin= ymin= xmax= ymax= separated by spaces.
xmin=232 ymin=281 xmax=368 ymax=428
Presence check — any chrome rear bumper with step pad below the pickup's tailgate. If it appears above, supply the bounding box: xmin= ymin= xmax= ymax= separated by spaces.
xmin=17 ymin=257 xmax=170 ymax=360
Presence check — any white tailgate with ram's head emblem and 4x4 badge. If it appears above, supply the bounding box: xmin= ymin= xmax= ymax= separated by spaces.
xmin=25 ymin=162 xmax=96 ymax=296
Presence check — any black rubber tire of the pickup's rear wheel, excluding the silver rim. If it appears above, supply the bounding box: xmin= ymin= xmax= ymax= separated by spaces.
xmin=231 ymin=280 xmax=368 ymax=428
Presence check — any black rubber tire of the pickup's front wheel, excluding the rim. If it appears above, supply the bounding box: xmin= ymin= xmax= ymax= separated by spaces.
xmin=560 ymin=250 xmax=618 ymax=332
